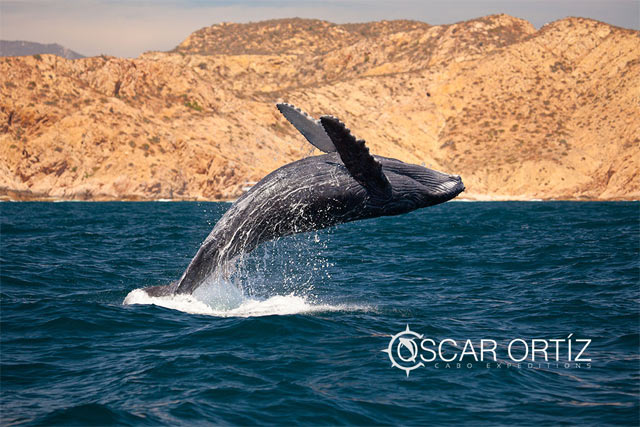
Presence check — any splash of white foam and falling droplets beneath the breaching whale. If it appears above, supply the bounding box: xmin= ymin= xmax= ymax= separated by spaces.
xmin=123 ymin=231 xmax=342 ymax=317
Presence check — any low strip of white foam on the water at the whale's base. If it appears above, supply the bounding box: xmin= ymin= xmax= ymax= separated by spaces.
xmin=123 ymin=289 xmax=372 ymax=317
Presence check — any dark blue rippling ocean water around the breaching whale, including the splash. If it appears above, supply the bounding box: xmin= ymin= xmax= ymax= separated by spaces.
xmin=0 ymin=202 xmax=640 ymax=425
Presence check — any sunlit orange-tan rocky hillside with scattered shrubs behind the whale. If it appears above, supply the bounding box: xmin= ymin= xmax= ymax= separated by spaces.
xmin=0 ymin=15 xmax=640 ymax=200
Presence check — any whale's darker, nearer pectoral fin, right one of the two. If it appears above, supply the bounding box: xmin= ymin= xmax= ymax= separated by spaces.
xmin=320 ymin=116 xmax=391 ymax=198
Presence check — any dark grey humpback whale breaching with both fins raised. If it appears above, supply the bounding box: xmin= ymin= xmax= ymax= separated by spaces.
xmin=144 ymin=103 xmax=464 ymax=296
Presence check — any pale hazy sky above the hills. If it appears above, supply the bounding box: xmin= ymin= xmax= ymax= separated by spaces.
xmin=0 ymin=0 xmax=640 ymax=57
